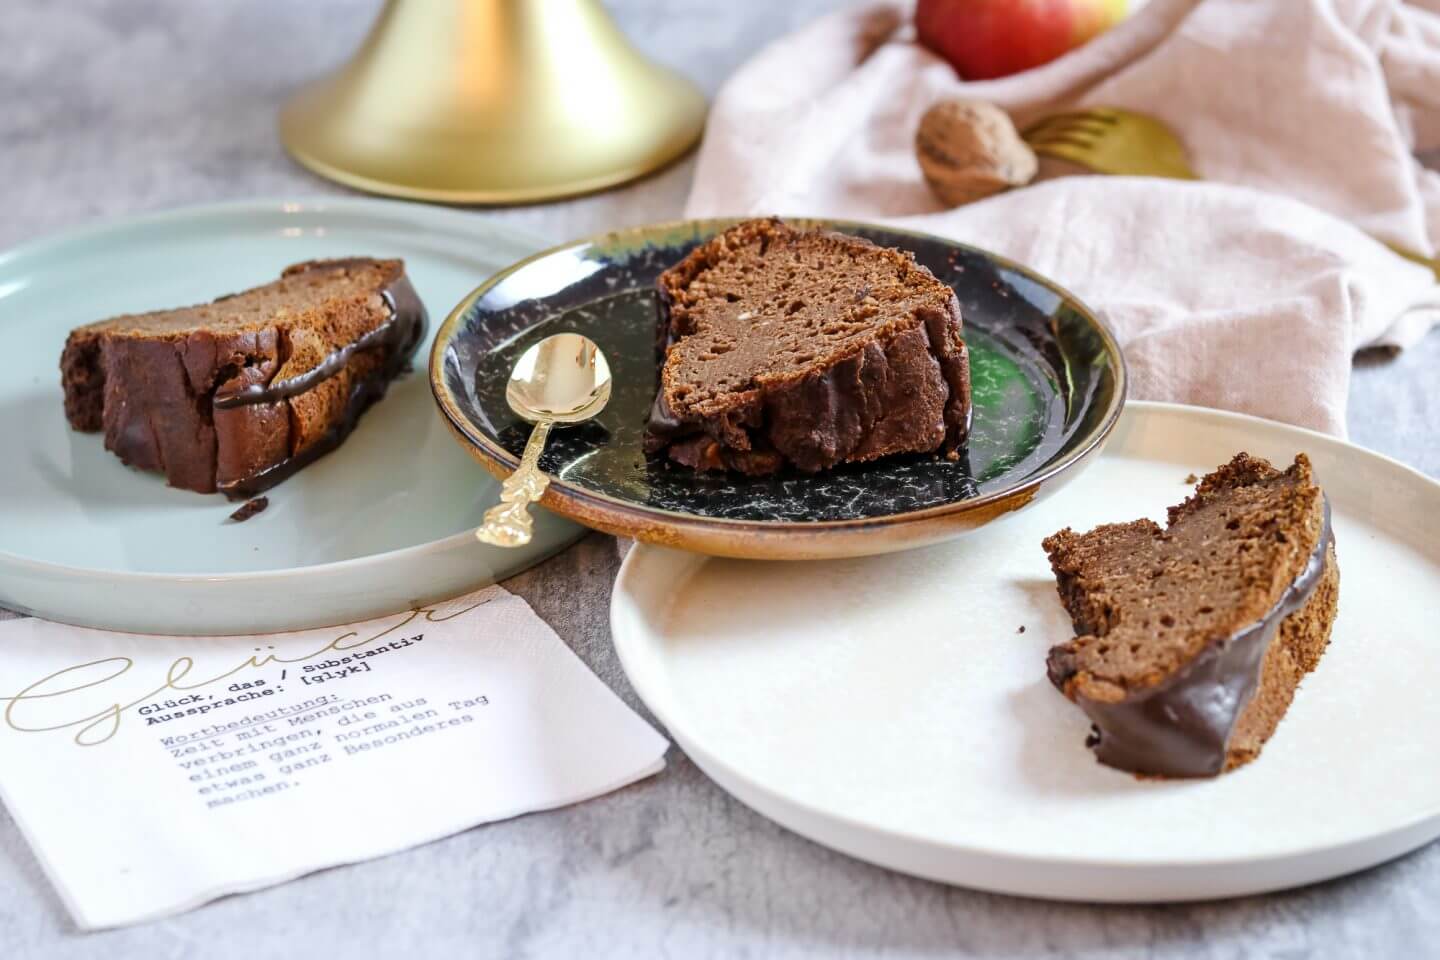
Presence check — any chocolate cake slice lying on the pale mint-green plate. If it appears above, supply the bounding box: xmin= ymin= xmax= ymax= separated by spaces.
xmin=60 ymin=258 xmax=426 ymax=499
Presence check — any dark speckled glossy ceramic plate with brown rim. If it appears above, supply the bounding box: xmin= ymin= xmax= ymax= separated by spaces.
xmin=431 ymin=219 xmax=1125 ymax=558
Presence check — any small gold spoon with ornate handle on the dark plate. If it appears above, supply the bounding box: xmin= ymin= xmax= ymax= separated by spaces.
xmin=475 ymin=334 xmax=611 ymax=547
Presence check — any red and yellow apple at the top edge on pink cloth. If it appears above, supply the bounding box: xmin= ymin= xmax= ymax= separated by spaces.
xmin=914 ymin=0 xmax=1128 ymax=81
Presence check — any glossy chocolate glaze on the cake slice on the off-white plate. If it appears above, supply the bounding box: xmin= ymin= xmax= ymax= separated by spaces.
xmin=1071 ymin=499 xmax=1335 ymax=777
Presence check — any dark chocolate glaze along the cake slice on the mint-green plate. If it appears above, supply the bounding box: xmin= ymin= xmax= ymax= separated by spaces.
xmin=215 ymin=275 xmax=426 ymax=499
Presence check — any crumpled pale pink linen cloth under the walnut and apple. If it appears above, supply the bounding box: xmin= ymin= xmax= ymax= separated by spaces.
xmin=687 ymin=0 xmax=1440 ymax=435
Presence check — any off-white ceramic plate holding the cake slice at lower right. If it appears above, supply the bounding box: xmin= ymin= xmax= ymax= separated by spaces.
xmin=611 ymin=403 xmax=1440 ymax=901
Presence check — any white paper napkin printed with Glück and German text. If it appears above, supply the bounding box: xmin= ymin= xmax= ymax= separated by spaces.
xmin=0 ymin=586 xmax=668 ymax=930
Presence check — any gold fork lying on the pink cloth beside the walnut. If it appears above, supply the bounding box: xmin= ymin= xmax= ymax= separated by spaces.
xmin=1021 ymin=107 xmax=1440 ymax=281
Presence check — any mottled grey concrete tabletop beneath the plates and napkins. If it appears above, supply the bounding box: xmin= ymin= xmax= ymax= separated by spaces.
xmin=0 ymin=0 xmax=1440 ymax=960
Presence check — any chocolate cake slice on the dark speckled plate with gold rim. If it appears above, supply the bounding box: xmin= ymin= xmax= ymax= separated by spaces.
xmin=645 ymin=219 xmax=971 ymax=475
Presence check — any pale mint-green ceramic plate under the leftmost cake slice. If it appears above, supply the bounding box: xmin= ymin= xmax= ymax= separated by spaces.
xmin=0 ymin=199 xmax=579 ymax=633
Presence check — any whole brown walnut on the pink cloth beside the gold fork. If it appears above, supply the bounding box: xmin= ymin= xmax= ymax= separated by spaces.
xmin=914 ymin=99 xmax=1037 ymax=207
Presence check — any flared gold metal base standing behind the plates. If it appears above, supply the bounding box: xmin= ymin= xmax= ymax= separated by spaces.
xmin=279 ymin=0 xmax=706 ymax=203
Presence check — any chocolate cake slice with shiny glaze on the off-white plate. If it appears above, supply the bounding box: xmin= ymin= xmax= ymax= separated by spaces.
xmin=1044 ymin=453 xmax=1339 ymax=777
